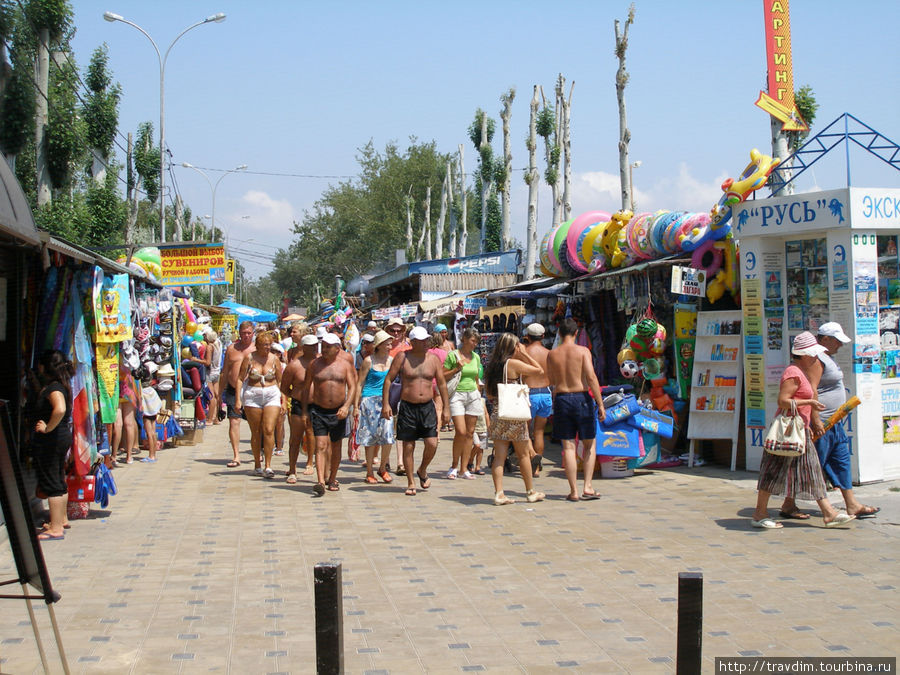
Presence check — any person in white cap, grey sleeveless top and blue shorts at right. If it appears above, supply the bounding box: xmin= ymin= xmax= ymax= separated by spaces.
xmin=779 ymin=321 xmax=881 ymax=520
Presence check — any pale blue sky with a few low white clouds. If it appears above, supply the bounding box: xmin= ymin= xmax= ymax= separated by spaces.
xmin=72 ymin=0 xmax=900 ymax=278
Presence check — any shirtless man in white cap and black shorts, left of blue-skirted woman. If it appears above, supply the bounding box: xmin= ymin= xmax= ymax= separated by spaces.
xmin=301 ymin=333 xmax=356 ymax=496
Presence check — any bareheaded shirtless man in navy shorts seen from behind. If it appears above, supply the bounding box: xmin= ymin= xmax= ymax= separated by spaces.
xmin=547 ymin=319 xmax=606 ymax=502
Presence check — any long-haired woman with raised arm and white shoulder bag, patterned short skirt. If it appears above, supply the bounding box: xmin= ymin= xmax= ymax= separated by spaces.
xmin=484 ymin=333 xmax=544 ymax=506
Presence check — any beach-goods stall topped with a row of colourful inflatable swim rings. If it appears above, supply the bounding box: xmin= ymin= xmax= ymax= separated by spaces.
xmin=538 ymin=149 xmax=778 ymax=472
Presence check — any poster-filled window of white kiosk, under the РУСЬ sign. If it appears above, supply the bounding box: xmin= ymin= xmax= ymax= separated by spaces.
xmin=784 ymin=238 xmax=829 ymax=334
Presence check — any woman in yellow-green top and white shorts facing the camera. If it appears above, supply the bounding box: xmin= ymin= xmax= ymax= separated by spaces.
xmin=444 ymin=328 xmax=484 ymax=480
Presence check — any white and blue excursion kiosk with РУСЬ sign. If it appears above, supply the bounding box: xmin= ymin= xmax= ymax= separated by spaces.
xmin=737 ymin=187 xmax=900 ymax=483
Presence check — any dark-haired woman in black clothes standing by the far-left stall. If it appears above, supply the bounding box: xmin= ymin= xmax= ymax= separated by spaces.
xmin=32 ymin=349 xmax=75 ymax=541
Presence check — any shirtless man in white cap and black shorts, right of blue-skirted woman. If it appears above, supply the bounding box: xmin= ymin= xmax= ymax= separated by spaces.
xmin=381 ymin=326 xmax=450 ymax=497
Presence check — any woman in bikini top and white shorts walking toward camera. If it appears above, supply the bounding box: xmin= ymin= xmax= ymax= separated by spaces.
xmin=234 ymin=333 xmax=287 ymax=478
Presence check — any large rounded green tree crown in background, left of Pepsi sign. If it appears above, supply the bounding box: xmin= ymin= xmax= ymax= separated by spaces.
xmin=270 ymin=138 xmax=447 ymax=305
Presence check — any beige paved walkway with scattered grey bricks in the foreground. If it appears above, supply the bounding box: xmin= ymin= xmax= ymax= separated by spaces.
xmin=0 ymin=426 xmax=900 ymax=673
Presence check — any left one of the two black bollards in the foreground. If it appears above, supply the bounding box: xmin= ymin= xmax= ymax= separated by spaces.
xmin=313 ymin=563 xmax=344 ymax=675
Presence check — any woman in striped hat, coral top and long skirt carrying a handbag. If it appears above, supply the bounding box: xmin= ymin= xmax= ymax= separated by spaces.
xmin=751 ymin=332 xmax=855 ymax=530
